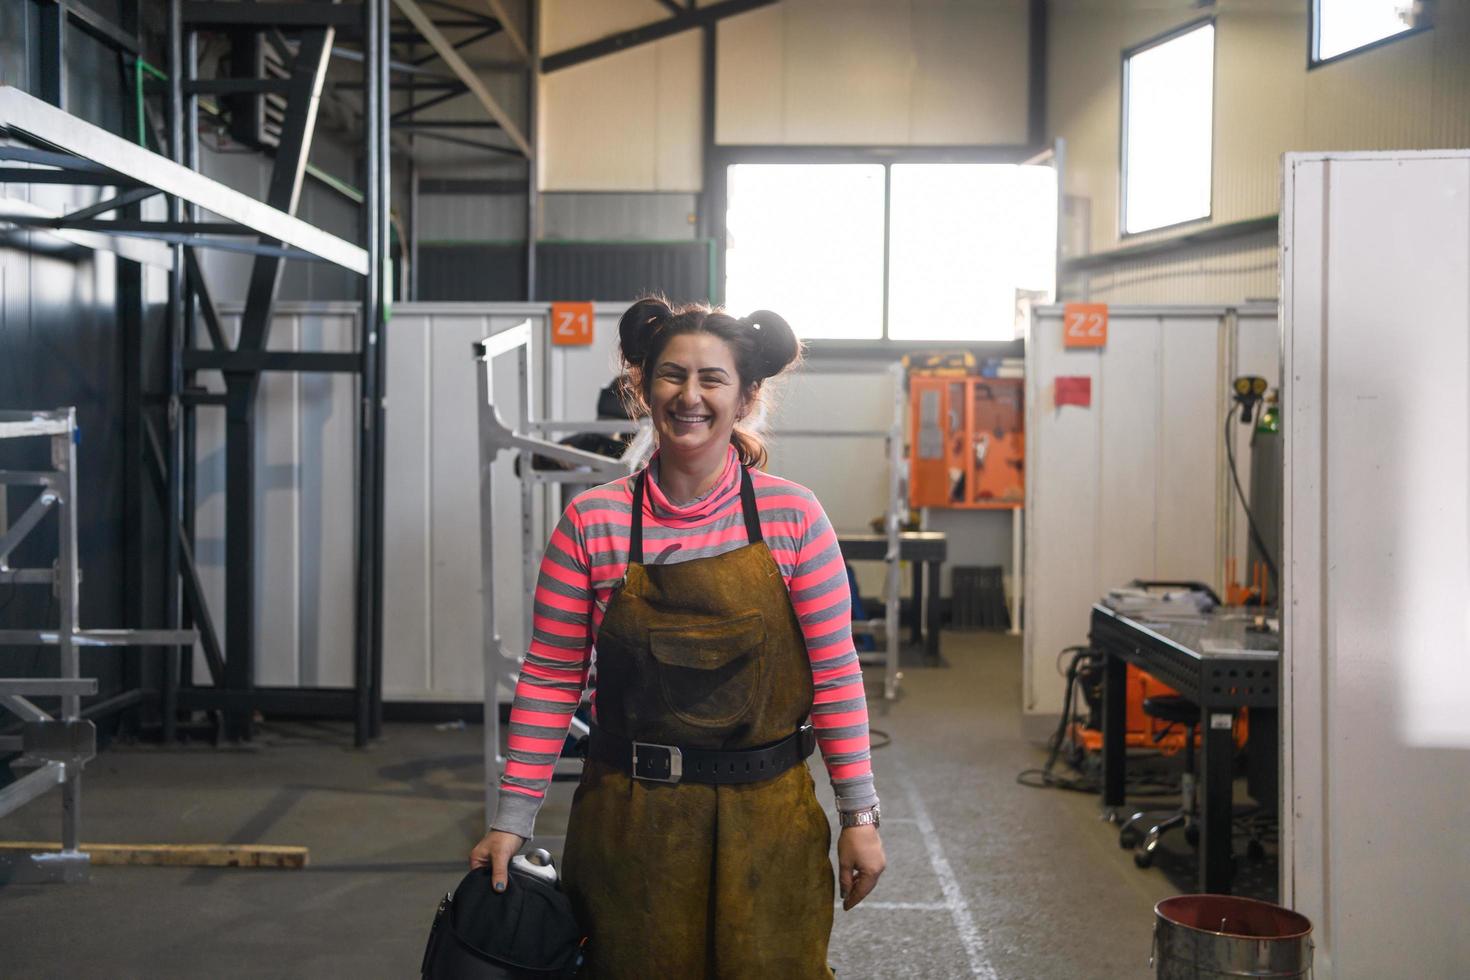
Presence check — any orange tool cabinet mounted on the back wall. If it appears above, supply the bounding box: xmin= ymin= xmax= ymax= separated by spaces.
xmin=908 ymin=376 xmax=1026 ymax=510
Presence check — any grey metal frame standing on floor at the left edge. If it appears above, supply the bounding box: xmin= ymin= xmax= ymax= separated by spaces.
xmin=0 ymin=408 xmax=197 ymax=882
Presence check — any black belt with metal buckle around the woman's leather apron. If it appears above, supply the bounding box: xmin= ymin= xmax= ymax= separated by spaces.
xmin=587 ymin=724 xmax=817 ymax=783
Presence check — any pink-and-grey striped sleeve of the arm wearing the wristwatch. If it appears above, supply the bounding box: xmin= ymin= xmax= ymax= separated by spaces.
xmin=788 ymin=485 xmax=878 ymax=813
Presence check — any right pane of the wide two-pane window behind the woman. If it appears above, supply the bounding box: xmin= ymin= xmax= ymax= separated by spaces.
xmin=888 ymin=163 xmax=1057 ymax=342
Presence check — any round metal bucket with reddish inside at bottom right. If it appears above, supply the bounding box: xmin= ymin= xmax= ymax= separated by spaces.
xmin=1150 ymin=895 xmax=1311 ymax=980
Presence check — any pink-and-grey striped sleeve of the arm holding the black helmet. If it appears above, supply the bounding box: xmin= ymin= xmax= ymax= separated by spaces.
xmin=491 ymin=507 xmax=595 ymax=839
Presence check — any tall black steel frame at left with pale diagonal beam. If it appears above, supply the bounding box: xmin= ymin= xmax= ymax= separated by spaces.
xmin=0 ymin=0 xmax=390 ymax=745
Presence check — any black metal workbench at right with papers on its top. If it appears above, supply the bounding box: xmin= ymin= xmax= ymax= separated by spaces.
xmin=1092 ymin=602 xmax=1280 ymax=895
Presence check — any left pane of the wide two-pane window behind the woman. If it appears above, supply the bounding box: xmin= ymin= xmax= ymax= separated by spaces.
xmin=725 ymin=163 xmax=883 ymax=339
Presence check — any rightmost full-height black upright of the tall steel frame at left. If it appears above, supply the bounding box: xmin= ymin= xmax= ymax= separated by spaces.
xmin=353 ymin=0 xmax=388 ymax=746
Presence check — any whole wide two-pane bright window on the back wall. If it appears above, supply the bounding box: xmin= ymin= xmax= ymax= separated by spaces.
xmin=725 ymin=163 xmax=1057 ymax=342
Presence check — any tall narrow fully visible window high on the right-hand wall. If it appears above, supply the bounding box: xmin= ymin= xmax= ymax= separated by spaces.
xmin=1123 ymin=22 xmax=1214 ymax=235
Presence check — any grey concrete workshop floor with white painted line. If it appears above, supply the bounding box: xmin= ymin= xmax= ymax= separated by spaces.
xmin=0 ymin=633 xmax=1199 ymax=980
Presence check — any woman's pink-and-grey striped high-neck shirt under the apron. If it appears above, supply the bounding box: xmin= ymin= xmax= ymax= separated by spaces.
xmin=494 ymin=448 xmax=878 ymax=837
